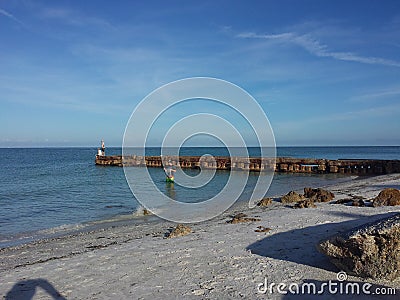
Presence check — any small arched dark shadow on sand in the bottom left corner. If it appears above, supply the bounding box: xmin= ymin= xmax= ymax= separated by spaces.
xmin=5 ymin=278 xmax=66 ymax=300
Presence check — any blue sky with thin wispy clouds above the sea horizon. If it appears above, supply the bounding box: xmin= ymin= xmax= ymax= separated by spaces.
xmin=0 ymin=0 xmax=400 ymax=147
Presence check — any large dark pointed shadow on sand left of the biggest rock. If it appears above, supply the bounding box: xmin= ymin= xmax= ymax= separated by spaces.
xmin=246 ymin=213 xmax=393 ymax=272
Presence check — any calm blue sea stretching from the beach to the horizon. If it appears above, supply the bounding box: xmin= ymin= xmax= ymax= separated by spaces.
xmin=0 ymin=146 xmax=400 ymax=248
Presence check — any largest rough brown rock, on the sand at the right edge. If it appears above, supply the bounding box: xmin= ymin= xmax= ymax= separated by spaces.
xmin=317 ymin=213 xmax=400 ymax=280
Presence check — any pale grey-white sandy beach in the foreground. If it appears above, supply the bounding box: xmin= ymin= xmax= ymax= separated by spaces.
xmin=0 ymin=174 xmax=400 ymax=299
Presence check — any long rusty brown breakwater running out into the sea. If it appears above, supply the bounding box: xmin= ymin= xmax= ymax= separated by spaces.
xmin=95 ymin=155 xmax=400 ymax=175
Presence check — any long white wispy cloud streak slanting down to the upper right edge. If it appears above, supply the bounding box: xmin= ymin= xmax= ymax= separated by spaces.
xmin=237 ymin=32 xmax=400 ymax=67
